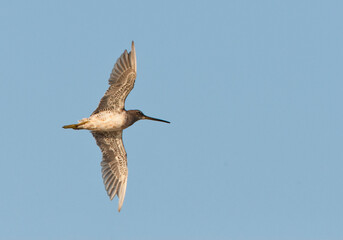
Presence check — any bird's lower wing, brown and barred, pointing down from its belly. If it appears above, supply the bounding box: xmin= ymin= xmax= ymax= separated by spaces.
xmin=92 ymin=131 xmax=128 ymax=211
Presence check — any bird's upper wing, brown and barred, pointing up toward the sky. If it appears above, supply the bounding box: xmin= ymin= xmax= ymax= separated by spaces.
xmin=92 ymin=42 xmax=137 ymax=115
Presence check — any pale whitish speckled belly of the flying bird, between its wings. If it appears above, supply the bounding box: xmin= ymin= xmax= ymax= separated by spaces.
xmin=81 ymin=112 xmax=126 ymax=131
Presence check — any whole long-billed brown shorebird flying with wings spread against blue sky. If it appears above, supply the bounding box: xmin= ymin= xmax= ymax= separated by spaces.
xmin=63 ymin=41 xmax=170 ymax=212
